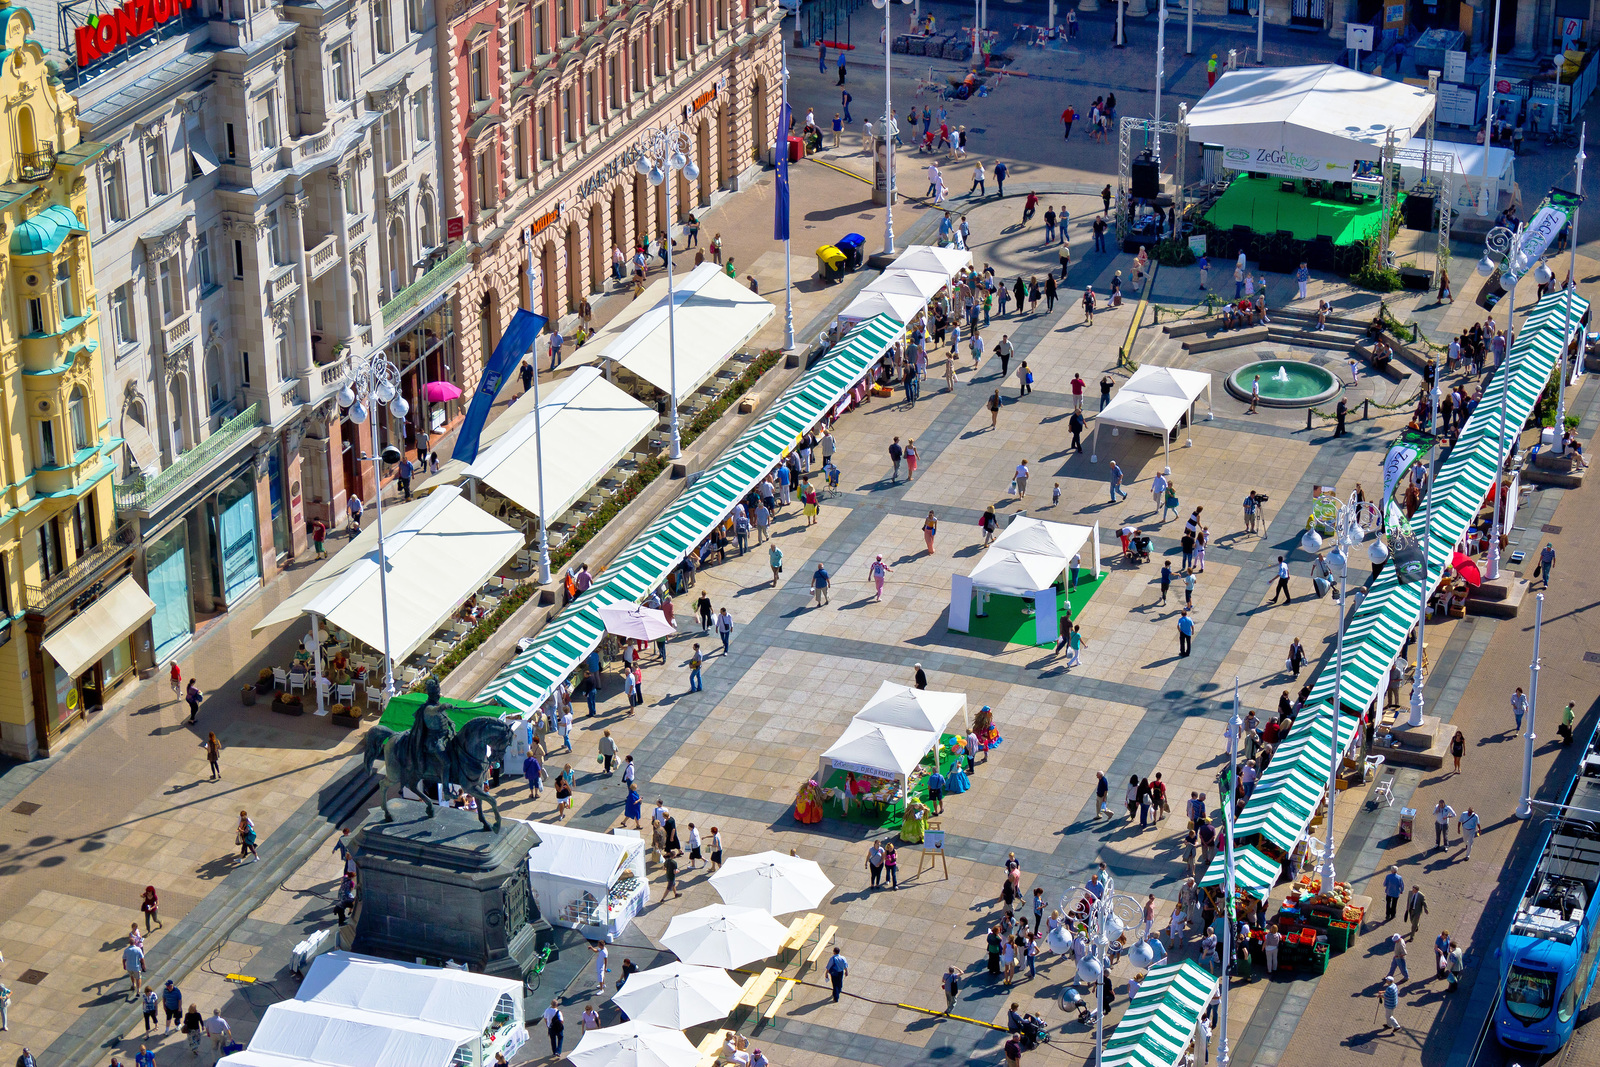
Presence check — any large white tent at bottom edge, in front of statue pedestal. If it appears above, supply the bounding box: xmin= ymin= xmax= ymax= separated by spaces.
xmin=221 ymin=952 xmax=528 ymax=1067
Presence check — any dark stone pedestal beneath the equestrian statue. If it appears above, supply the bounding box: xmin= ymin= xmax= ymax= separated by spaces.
xmin=352 ymin=800 xmax=549 ymax=979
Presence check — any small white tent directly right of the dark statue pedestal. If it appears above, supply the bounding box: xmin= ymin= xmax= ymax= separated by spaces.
xmin=528 ymin=822 xmax=650 ymax=941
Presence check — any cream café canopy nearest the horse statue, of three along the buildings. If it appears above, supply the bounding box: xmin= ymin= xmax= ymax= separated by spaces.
xmin=251 ymin=486 xmax=523 ymax=662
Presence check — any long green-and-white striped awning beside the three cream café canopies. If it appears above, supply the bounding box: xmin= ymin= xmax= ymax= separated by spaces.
xmin=478 ymin=315 xmax=904 ymax=712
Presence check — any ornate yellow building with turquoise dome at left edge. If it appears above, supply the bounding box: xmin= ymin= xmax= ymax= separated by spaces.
xmin=0 ymin=0 xmax=140 ymax=758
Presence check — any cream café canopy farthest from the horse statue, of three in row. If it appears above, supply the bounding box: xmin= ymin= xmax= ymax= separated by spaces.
xmin=598 ymin=262 xmax=778 ymax=403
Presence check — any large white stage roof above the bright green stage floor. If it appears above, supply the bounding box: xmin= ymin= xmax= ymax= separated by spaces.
xmin=1187 ymin=64 xmax=1434 ymax=167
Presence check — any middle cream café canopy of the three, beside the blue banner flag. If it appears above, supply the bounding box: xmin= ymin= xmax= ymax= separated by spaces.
xmin=466 ymin=366 xmax=656 ymax=520
